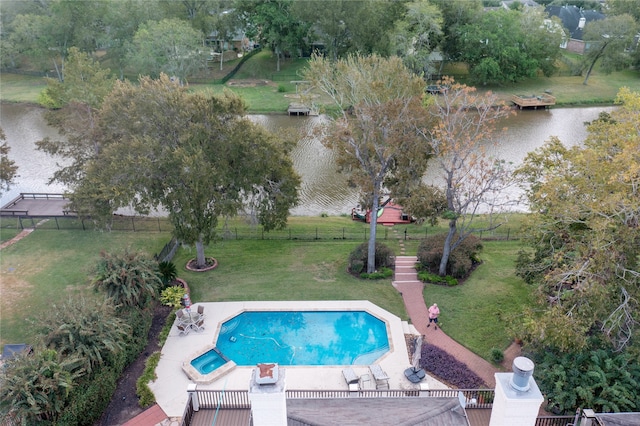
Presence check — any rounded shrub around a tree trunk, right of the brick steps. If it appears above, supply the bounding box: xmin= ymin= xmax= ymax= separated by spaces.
xmin=418 ymin=234 xmax=482 ymax=285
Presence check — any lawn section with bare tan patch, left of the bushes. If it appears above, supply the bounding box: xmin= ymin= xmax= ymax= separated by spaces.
xmin=0 ymin=230 xmax=170 ymax=345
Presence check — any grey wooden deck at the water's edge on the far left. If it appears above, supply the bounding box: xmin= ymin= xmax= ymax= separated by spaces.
xmin=0 ymin=193 xmax=76 ymax=217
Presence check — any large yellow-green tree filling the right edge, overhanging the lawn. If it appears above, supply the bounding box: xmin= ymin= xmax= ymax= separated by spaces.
xmin=518 ymin=89 xmax=640 ymax=356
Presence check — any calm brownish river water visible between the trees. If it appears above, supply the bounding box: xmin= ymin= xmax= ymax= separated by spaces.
xmin=0 ymin=104 xmax=613 ymax=216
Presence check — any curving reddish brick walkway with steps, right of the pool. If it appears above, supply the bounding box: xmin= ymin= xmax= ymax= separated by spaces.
xmin=393 ymin=229 xmax=520 ymax=388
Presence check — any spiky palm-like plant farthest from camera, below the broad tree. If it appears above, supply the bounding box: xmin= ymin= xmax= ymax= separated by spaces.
xmin=94 ymin=250 xmax=162 ymax=307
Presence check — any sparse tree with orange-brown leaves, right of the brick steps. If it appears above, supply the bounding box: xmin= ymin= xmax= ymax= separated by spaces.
xmin=421 ymin=79 xmax=513 ymax=276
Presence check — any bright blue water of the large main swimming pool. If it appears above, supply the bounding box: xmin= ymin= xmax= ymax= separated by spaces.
xmin=216 ymin=311 xmax=389 ymax=366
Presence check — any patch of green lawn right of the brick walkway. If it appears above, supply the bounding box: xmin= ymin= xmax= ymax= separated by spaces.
xmin=424 ymin=241 xmax=532 ymax=359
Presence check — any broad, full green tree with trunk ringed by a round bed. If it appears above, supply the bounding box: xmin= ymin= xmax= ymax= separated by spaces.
xmin=71 ymin=74 xmax=300 ymax=267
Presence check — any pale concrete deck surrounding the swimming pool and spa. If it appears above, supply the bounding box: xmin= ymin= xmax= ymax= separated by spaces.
xmin=149 ymin=300 xmax=447 ymax=418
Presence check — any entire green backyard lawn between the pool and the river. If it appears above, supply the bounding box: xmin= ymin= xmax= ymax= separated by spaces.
xmin=0 ymin=215 xmax=529 ymax=357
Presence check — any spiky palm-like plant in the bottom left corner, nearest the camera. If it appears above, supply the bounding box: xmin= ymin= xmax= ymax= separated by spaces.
xmin=0 ymin=349 xmax=82 ymax=424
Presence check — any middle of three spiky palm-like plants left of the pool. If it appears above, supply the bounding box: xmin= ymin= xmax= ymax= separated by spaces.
xmin=41 ymin=299 xmax=131 ymax=373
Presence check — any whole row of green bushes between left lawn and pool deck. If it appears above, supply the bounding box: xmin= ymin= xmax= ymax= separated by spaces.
xmin=0 ymin=250 xmax=159 ymax=426
